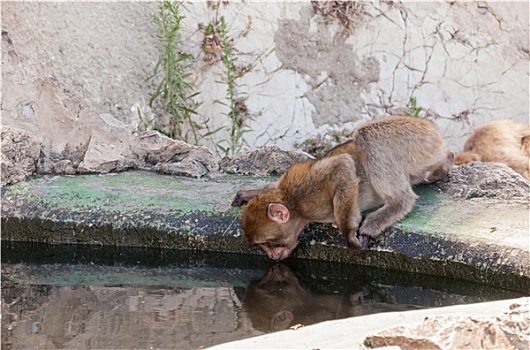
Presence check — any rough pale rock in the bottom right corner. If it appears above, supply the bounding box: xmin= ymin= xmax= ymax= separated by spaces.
xmin=365 ymin=304 xmax=530 ymax=349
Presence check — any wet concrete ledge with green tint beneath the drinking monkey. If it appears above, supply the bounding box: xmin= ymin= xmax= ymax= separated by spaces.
xmin=2 ymin=171 xmax=530 ymax=292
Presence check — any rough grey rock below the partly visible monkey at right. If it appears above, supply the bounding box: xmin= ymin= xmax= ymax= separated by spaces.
xmin=436 ymin=162 xmax=530 ymax=199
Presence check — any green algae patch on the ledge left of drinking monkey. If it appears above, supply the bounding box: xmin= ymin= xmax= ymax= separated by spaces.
xmin=4 ymin=172 xmax=218 ymax=213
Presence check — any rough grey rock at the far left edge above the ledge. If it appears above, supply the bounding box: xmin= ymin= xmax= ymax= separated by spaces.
xmin=1 ymin=126 xmax=42 ymax=186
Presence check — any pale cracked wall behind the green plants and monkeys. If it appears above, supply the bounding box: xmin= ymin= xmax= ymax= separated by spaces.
xmin=1 ymin=1 xmax=529 ymax=156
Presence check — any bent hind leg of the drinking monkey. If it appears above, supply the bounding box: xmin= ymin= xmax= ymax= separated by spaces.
xmin=359 ymin=176 xmax=418 ymax=244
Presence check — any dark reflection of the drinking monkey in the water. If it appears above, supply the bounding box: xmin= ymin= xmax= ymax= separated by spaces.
xmin=236 ymin=263 xmax=417 ymax=332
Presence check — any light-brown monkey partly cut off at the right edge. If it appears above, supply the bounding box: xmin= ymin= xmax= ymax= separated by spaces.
xmin=454 ymin=119 xmax=530 ymax=180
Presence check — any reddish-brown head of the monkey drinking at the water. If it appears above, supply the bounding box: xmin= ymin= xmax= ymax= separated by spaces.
xmin=241 ymin=190 xmax=307 ymax=260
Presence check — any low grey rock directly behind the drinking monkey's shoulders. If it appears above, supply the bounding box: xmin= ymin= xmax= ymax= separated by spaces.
xmin=219 ymin=146 xmax=314 ymax=176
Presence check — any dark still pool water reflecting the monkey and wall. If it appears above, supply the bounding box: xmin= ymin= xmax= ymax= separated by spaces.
xmin=2 ymin=242 xmax=523 ymax=349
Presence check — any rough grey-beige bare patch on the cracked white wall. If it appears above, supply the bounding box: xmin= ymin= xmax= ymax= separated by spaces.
xmin=275 ymin=8 xmax=379 ymax=126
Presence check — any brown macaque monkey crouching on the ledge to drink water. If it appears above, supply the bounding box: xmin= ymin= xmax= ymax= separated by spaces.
xmin=232 ymin=117 xmax=453 ymax=260
